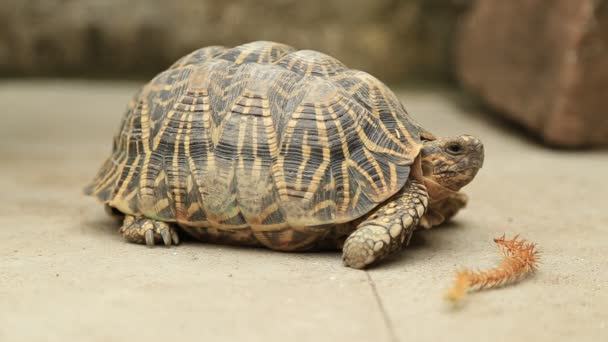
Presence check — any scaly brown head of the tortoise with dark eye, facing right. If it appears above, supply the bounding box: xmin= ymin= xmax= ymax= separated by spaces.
xmin=421 ymin=135 xmax=484 ymax=191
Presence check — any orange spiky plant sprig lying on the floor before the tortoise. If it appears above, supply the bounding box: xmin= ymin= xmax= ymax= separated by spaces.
xmin=445 ymin=235 xmax=540 ymax=302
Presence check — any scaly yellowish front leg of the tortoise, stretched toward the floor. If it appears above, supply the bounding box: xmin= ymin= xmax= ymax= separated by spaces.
xmin=342 ymin=180 xmax=428 ymax=268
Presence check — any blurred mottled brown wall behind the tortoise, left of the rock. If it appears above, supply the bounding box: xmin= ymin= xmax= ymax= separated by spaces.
xmin=0 ymin=0 xmax=463 ymax=80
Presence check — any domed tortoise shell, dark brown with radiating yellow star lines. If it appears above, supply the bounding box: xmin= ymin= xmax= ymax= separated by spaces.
xmin=86 ymin=41 xmax=423 ymax=250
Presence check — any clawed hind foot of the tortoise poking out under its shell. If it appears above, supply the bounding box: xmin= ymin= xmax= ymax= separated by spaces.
xmin=120 ymin=215 xmax=179 ymax=246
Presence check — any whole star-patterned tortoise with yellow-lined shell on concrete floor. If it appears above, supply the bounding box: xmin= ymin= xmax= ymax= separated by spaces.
xmin=85 ymin=41 xmax=484 ymax=268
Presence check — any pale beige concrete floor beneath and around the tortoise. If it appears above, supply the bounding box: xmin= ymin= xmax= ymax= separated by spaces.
xmin=0 ymin=81 xmax=608 ymax=342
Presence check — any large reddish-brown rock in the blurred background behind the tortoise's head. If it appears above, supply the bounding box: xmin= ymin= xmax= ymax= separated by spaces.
xmin=456 ymin=0 xmax=608 ymax=146
